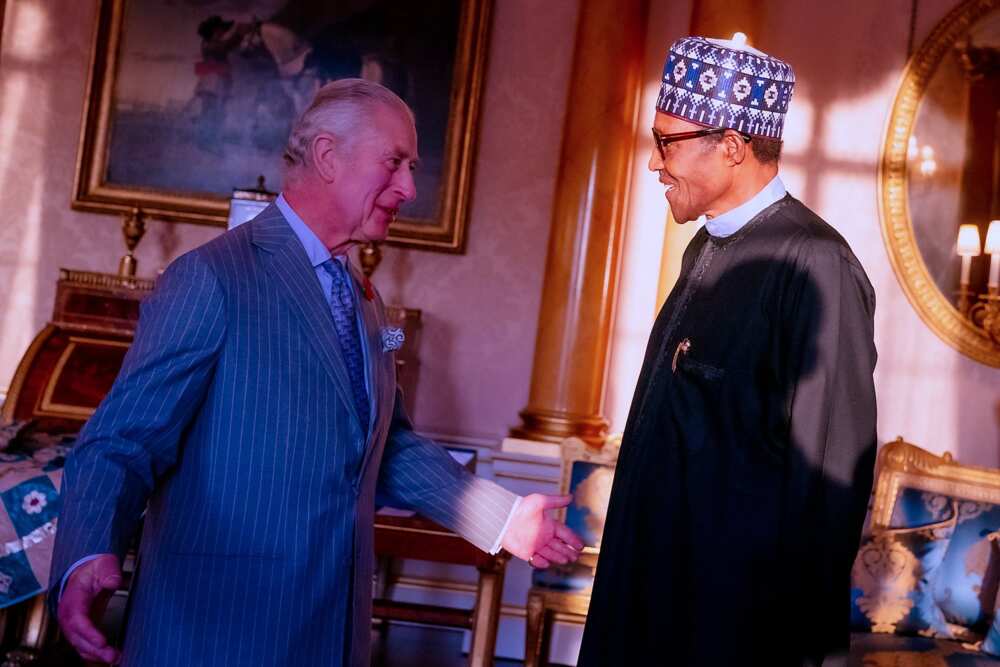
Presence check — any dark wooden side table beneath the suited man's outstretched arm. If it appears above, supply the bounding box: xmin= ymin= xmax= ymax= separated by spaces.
xmin=372 ymin=514 xmax=510 ymax=667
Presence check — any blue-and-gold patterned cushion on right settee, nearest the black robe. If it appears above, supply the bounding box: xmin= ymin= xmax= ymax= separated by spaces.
xmin=851 ymin=510 xmax=955 ymax=638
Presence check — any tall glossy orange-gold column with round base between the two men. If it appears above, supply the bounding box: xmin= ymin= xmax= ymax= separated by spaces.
xmin=511 ymin=0 xmax=647 ymax=443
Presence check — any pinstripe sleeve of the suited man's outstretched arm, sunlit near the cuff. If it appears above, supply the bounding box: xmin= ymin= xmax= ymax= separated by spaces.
xmin=378 ymin=389 xmax=517 ymax=551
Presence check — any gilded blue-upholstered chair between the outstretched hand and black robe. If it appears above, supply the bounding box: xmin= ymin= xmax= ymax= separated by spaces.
xmin=524 ymin=437 xmax=621 ymax=667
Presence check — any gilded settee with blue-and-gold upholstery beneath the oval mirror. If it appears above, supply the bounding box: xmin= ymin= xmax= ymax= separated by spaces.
xmin=851 ymin=438 xmax=1000 ymax=667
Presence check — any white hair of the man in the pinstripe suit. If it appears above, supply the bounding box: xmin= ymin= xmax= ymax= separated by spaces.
xmin=282 ymin=79 xmax=413 ymax=172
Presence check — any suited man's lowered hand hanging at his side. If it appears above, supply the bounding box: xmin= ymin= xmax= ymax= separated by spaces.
xmin=58 ymin=554 xmax=122 ymax=664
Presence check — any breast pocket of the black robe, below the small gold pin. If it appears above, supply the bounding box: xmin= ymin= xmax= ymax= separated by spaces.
xmin=670 ymin=354 xmax=726 ymax=452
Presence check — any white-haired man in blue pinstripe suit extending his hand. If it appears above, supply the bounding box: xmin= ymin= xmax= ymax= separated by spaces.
xmin=50 ymin=79 xmax=581 ymax=667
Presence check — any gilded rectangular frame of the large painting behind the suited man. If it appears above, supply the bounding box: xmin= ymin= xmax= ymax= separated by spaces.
xmin=70 ymin=0 xmax=493 ymax=253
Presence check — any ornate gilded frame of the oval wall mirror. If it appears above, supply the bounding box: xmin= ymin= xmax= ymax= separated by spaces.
xmin=879 ymin=0 xmax=1000 ymax=368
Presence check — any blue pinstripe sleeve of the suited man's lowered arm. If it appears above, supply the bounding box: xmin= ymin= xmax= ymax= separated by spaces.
xmin=49 ymin=253 xmax=225 ymax=582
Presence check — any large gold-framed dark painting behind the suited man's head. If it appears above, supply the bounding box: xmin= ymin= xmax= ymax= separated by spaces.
xmin=72 ymin=0 xmax=492 ymax=252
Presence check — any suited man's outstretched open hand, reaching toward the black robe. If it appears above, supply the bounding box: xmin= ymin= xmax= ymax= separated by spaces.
xmin=502 ymin=493 xmax=583 ymax=569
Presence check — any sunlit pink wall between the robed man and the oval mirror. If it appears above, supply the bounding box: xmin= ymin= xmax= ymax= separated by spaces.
xmin=760 ymin=0 xmax=1000 ymax=466
